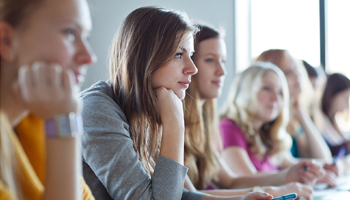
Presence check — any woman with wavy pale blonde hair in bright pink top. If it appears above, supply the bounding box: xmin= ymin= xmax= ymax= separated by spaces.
xmin=220 ymin=62 xmax=323 ymax=184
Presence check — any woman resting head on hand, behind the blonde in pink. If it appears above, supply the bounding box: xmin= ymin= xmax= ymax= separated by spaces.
xmin=256 ymin=49 xmax=338 ymax=186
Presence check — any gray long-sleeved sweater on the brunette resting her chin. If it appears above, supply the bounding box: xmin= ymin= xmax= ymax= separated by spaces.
xmin=81 ymin=81 xmax=205 ymax=200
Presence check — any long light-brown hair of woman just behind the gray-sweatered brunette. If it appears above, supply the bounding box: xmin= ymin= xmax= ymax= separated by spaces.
xmin=183 ymin=25 xmax=220 ymax=190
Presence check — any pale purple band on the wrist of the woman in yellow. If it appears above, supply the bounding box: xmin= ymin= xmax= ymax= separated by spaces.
xmin=45 ymin=113 xmax=83 ymax=139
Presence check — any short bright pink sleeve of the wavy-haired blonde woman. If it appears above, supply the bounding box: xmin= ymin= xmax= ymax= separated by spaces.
xmin=219 ymin=119 xmax=248 ymax=150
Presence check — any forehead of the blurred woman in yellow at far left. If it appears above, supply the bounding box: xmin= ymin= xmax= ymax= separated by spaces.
xmin=29 ymin=0 xmax=92 ymax=30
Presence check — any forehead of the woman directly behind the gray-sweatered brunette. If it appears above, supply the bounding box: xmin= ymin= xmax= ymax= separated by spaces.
xmin=196 ymin=38 xmax=226 ymax=56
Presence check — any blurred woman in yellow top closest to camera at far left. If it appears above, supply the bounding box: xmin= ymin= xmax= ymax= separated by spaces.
xmin=0 ymin=0 xmax=94 ymax=200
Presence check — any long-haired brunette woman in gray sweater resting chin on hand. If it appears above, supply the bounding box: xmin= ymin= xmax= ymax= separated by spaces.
xmin=81 ymin=7 xmax=271 ymax=200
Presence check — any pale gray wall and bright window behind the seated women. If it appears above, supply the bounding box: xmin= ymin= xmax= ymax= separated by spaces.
xmin=83 ymin=0 xmax=350 ymax=114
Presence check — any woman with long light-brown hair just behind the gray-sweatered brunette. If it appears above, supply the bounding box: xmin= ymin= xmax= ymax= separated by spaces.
xmin=184 ymin=25 xmax=320 ymax=198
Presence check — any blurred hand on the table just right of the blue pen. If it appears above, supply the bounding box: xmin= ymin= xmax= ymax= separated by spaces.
xmin=265 ymin=182 xmax=313 ymax=200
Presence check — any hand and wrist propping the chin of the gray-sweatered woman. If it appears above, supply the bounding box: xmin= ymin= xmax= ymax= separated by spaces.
xmin=155 ymin=87 xmax=185 ymax=131
